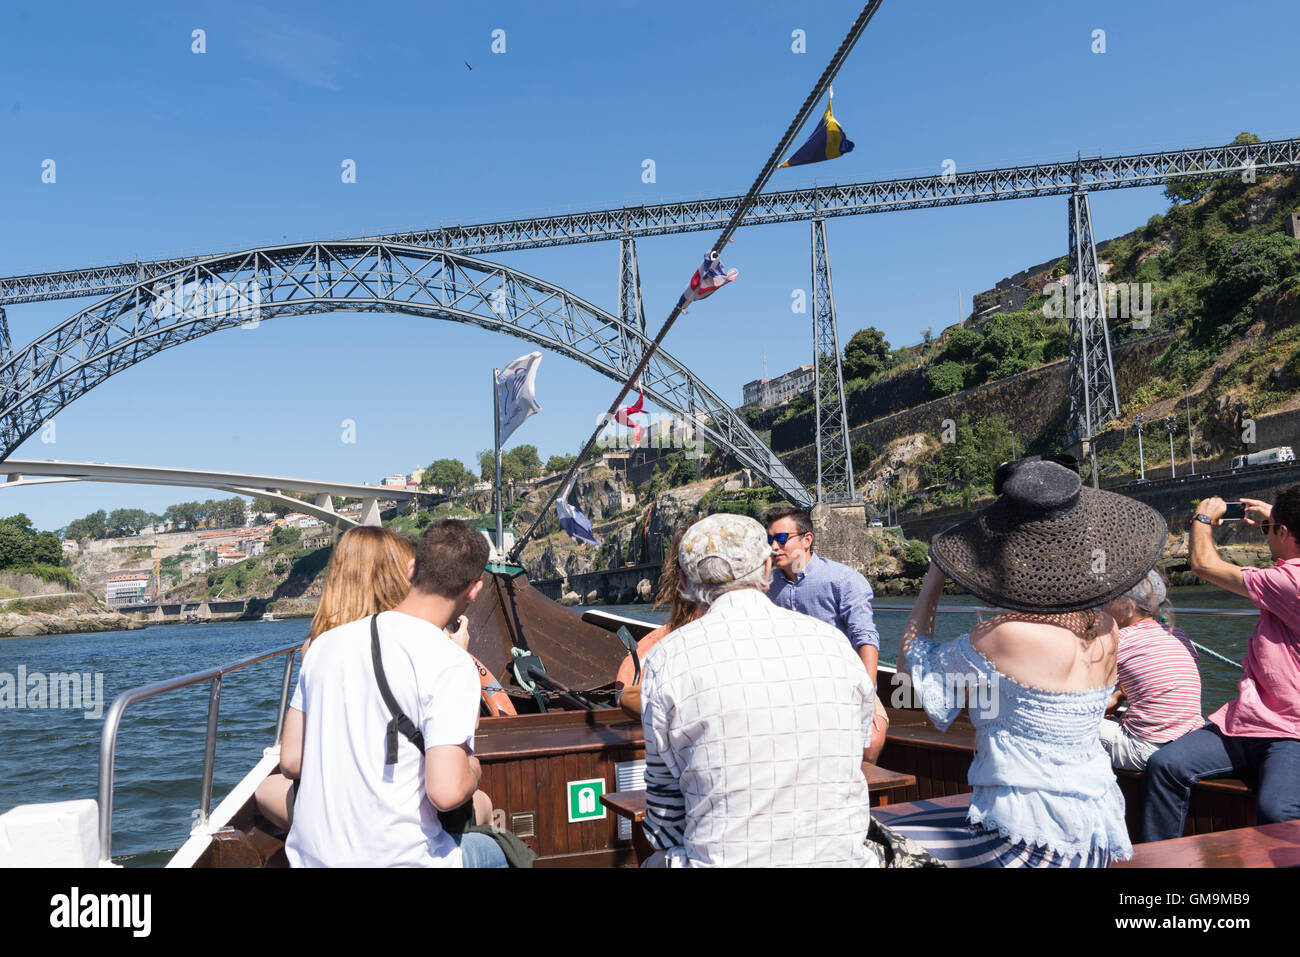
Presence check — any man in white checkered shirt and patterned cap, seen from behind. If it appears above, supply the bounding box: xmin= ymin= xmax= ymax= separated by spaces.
xmin=641 ymin=515 xmax=879 ymax=867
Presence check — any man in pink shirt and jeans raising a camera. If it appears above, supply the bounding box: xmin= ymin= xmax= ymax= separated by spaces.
xmin=1143 ymin=485 xmax=1300 ymax=841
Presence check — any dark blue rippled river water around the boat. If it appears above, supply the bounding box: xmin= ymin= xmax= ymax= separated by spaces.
xmin=0 ymin=588 xmax=1255 ymax=866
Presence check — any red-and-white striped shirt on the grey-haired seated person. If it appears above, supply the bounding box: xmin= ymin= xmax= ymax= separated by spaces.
xmin=1115 ymin=618 xmax=1205 ymax=744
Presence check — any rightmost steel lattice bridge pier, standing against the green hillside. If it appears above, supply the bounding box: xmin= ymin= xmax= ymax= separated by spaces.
xmin=1065 ymin=191 xmax=1119 ymax=445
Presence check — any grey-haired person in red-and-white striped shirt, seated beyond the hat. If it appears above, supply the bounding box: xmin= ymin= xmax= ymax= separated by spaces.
xmin=1101 ymin=570 xmax=1205 ymax=771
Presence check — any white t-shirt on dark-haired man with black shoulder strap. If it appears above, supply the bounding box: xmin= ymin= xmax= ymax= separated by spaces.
xmin=285 ymin=611 xmax=480 ymax=867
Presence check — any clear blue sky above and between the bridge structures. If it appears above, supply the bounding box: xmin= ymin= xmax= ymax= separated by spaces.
xmin=0 ymin=0 xmax=1300 ymax=528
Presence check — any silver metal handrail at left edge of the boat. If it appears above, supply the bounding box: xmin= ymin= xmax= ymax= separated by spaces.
xmin=99 ymin=644 xmax=302 ymax=863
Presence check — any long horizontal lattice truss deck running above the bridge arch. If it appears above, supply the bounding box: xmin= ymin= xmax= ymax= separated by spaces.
xmin=0 ymin=139 xmax=1300 ymax=306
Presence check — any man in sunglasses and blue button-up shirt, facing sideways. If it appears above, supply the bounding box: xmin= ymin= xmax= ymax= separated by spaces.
xmin=763 ymin=505 xmax=889 ymax=761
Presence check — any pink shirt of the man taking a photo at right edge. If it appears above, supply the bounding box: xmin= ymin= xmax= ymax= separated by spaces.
xmin=1210 ymin=558 xmax=1300 ymax=739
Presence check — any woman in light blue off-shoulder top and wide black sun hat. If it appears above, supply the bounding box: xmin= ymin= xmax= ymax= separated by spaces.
xmin=888 ymin=456 xmax=1167 ymax=867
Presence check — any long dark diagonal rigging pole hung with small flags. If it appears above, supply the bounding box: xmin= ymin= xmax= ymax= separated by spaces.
xmin=508 ymin=0 xmax=883 ymax=562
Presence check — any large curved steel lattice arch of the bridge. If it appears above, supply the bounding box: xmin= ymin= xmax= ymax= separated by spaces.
xmin=0 ymin=241 xmax=813 ymax=507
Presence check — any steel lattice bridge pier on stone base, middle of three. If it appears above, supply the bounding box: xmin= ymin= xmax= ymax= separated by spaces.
xmin=813 ymin=218 xmax=858 ymax=502
